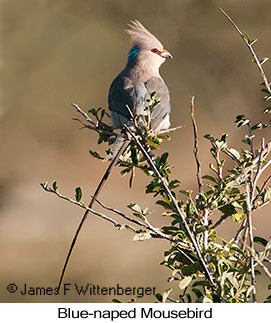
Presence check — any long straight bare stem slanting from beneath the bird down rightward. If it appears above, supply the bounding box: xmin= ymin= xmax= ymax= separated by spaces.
xmin=124 ymin=125 xmax=215 ymax=288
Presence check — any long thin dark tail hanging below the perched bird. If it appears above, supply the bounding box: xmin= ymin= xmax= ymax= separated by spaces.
xmin=57 ymin=136 xmax=130 ymax=292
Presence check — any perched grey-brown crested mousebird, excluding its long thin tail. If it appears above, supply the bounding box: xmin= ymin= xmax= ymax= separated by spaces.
xmin=105 ymin=20 xmax=173 ymax=161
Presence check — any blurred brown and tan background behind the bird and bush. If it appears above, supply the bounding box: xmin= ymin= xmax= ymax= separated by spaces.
xmin=0 ymin=0 xmax=271 ymax=302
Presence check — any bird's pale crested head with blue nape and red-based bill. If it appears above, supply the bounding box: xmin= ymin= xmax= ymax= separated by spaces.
xmin=126 ymin=20 xmax=173 ymax=73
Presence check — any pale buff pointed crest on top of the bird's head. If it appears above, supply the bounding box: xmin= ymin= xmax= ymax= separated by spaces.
xmin=126 ymin=20 xmax=163 ymax=50
